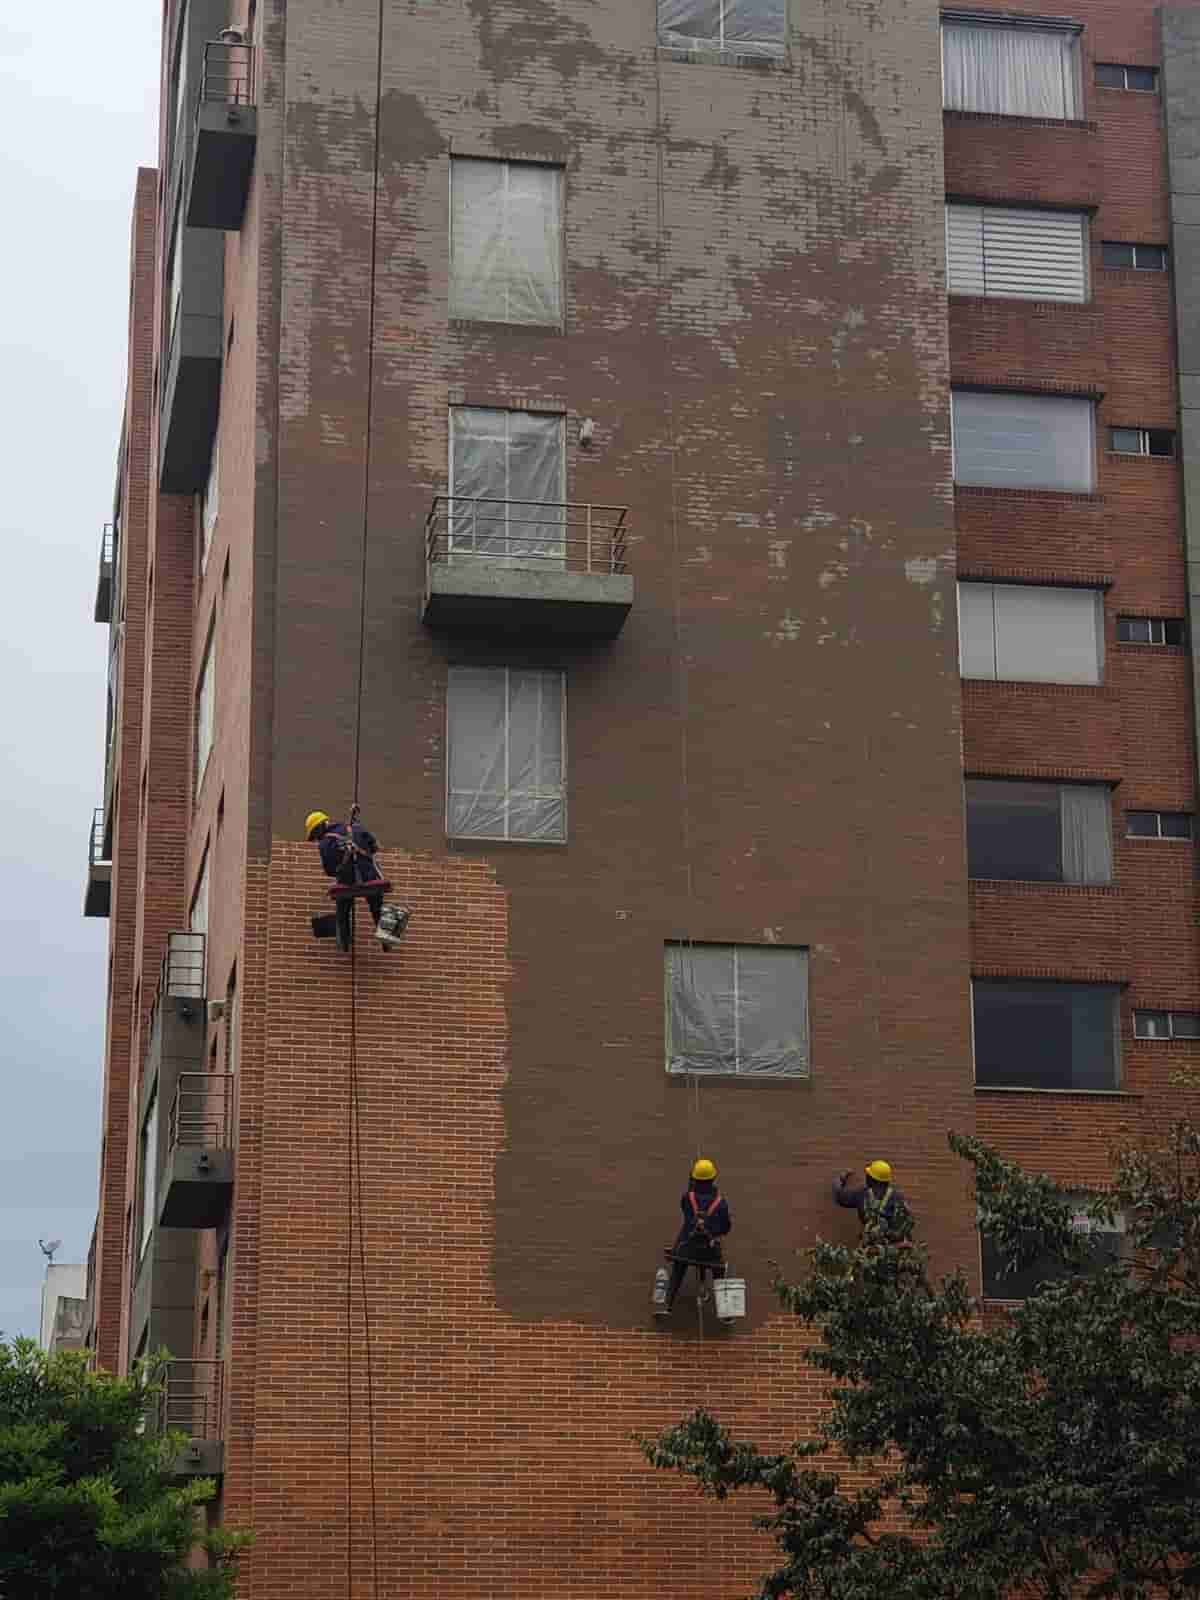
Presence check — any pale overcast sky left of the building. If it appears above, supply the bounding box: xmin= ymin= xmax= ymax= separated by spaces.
xmin=0 ymin=0 xmax=160 ymax=1334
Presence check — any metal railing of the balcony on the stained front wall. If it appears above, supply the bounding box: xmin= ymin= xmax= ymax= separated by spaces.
xmin=426 ymin=494 xmax=629 ymax=576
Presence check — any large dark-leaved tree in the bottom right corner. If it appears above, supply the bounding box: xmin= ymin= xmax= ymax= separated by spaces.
xmin=642 ymin=1120 xmax=1200 ymax=1600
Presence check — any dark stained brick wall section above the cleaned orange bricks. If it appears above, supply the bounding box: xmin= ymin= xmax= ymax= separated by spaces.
xmin=254 ymin=0 xmax=974 ymax=1325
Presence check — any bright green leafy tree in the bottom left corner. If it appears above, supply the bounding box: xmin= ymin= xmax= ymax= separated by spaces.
xmin=0 ymin=1339 xmax=246 ymax=1600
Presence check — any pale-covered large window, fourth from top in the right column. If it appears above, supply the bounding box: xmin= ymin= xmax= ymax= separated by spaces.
xmin=958 ymin=582 xmax=1104 ymax=683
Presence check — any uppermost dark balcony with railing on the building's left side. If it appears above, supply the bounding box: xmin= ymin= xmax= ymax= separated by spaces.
xmin=187 ymin=38 xmax=258 ymax=230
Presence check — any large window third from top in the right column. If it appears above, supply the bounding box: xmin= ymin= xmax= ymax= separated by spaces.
xmin=950 ymin=389 xmax=1094 ymax=493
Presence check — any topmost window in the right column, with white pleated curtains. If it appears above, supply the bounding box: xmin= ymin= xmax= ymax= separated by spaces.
xmin=942 ymin=13 xmax=1080 ymax=120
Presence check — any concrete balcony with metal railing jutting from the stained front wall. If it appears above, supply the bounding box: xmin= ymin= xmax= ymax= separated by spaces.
xmin=422 ymin=494 xmax=634 ymax=640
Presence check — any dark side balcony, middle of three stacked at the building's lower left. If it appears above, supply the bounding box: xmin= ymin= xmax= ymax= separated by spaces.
xmin=158 ymin=1072 xmax=234 ymax=1227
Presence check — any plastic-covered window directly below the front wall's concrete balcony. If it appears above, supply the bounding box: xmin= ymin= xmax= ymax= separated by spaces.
xmin=446 ymin=667 xmax=566 ymax=843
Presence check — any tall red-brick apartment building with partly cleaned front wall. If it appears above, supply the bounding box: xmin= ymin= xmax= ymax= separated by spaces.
xmin=80 ymin=0 xmax=1200 ymax=1600
